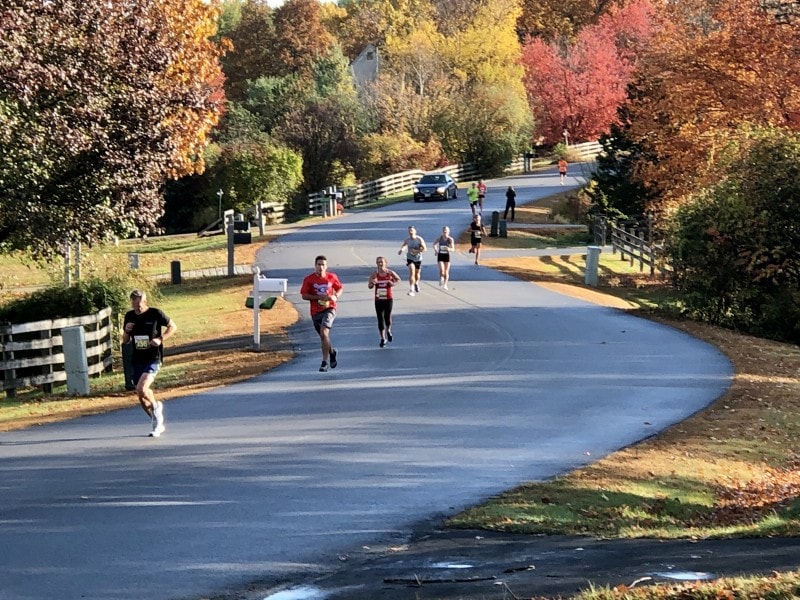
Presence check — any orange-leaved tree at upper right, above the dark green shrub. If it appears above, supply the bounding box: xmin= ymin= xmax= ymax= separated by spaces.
xmin=629 ymin=0 xmax=800 ymax=212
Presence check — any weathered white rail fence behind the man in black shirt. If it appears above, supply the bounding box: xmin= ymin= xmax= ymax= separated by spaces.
xmin=0 ymin=308 xmax=113 ymax=398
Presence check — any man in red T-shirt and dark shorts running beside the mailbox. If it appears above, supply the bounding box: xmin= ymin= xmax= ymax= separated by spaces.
xmin=300 ymin=256 xmax=344 ymax=372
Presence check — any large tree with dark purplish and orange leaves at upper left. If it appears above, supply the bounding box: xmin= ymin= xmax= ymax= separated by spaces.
xmin=0 ymin=0 xmax=224 ymax=257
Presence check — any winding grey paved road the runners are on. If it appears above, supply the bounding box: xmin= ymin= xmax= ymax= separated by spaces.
xmin=0 ymin=165 xmax=731 ymax=600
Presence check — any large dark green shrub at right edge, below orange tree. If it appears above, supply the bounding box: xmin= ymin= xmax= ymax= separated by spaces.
xmin=669 ymin=130 xmax=800 ymax=343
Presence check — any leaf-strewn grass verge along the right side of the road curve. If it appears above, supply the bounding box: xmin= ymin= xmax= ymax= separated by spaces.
xmin=448 ymin=250 xmax=800 ymax=538
